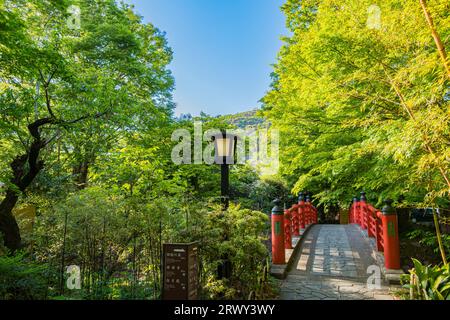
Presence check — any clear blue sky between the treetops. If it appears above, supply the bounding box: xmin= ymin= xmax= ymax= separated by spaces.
xmin=127 ymin=0 xmax=287 ymax=116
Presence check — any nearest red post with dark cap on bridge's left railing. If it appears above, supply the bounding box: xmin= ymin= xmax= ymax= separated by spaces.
xmin=271 ymin=199 xmax=286 ymax=264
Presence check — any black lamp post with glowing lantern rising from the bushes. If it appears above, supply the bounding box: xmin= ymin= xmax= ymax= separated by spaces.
xmin=213 ymin=131 xmax=237 ymax=279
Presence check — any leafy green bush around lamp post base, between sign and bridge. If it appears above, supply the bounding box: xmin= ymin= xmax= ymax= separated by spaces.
xmin=189 ymin=205 xmax=273 ymax=299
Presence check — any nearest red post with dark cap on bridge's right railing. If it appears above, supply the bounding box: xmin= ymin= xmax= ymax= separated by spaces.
xmin=381 ymin=199 xmax=400 ymax=270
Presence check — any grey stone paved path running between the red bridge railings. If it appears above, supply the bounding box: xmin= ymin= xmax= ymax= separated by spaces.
xmin=280 ymin=225 xmax=393 ymax=300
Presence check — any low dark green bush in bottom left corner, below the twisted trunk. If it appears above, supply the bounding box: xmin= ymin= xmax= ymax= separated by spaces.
xmin=0 ymin=253 xmax=47 ymax=300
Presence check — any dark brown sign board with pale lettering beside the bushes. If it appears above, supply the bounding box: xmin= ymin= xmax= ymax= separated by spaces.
xmin=163 ymin=243 xmax=198 ymax=300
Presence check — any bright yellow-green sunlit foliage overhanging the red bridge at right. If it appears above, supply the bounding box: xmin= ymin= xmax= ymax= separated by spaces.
xmin=264 ymin=0 xmax=450 ymax=208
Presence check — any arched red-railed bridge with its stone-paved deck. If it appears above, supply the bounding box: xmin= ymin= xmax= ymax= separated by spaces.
xmin=271 ymin=192 xmax=403 ymax=299
